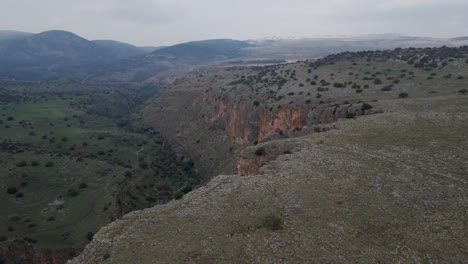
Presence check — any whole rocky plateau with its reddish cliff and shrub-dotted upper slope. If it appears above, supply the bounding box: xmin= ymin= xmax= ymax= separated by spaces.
xmin=69 ymin=47 xmax=468 ymax=263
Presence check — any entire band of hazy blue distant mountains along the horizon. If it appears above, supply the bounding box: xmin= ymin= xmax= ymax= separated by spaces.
xmin=0 ymin=30 xmax=468 ymax=82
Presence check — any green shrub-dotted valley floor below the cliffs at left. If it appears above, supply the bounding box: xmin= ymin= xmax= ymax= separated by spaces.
xmin=0 ymin=80 xmax=201 ymax=263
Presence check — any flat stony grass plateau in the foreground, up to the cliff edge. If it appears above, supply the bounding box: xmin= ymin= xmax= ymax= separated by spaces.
xmin=69 ymin=92 xmax=468 ymax=264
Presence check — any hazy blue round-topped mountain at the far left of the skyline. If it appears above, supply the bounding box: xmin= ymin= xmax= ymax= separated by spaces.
xmin=0 ymin=30 xmax=157 ymax=79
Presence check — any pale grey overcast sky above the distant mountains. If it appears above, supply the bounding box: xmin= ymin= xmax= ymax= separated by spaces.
xmin=0 ymin=0 xmax=468 ymax=45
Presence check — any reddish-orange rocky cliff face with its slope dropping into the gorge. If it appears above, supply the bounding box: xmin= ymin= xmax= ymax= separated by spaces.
xmin=135 ymin=67 xmax=379 ymax=177
